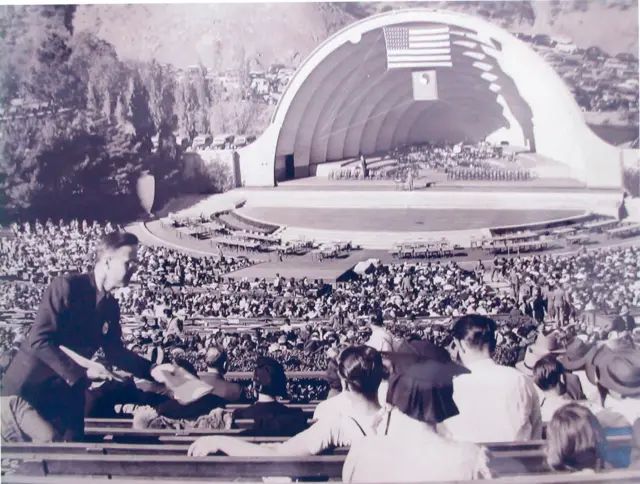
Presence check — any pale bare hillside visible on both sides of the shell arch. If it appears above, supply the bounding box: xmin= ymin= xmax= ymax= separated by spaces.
xmin=74 ymin=0 xmax=638 ymax=69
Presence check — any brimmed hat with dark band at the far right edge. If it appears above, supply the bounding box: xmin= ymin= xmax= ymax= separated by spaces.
xmin=586 ymin=340 xmax=640 ymax=397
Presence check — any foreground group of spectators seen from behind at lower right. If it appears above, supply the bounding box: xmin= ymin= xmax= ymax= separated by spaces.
xmin=176 ymin=315 xmax=640 ymax=482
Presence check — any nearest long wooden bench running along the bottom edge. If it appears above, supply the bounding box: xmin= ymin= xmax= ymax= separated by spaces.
xmin=3 ymin=441 xmax=640 ymax=482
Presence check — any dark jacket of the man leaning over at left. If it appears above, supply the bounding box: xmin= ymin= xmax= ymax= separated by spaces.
xmin=2 ymin=273 xmax=151 ymax=438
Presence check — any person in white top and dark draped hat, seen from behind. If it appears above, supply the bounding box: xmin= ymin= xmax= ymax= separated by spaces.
xmin=342 ymin=360 xmax=490 ymax=482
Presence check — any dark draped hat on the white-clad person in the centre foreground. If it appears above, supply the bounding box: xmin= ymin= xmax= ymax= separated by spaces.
xmin=387 ymin=360 xmax=469 ymax=424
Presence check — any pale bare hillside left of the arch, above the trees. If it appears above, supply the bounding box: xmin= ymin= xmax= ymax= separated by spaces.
xmin=74 ymin=3 xmax=353 ymax=69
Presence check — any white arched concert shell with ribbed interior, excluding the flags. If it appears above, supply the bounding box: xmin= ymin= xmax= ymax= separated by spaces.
xmin=239 ymin=9 xmax=623 ymax=188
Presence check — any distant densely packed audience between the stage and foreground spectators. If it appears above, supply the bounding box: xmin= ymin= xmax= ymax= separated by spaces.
xmin=0 ymin=222 xmax=640 ymax=386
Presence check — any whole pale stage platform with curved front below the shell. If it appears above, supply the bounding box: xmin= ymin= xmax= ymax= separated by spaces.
xmin=169 ymin=177 xmax=622 ymax=250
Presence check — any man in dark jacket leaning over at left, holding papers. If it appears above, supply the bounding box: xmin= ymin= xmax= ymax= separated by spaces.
xmin=2 ymin=232 xmax=158 ymax=441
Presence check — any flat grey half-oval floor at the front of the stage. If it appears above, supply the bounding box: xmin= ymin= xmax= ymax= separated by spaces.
xmin=238 ymin=206 xmax=584 ymax=232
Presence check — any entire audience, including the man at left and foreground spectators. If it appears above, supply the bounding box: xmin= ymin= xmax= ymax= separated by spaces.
xmin=0 ymin=221 xmax=640 ymax=482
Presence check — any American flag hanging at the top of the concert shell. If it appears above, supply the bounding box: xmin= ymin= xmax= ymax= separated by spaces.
xmin=384 ymin=27 xmax=453 ymax=69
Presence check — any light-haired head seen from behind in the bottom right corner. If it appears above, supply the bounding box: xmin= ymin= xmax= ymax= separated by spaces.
xmin=546 ymin=403 xmax=606 ymax=471
